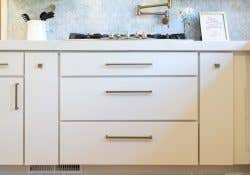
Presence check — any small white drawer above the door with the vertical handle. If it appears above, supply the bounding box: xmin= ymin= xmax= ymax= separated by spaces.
xmin=0 ymin=52 xmax=24 ymax=76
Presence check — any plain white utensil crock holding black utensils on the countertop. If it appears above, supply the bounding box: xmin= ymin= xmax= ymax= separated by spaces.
xmin=27 ymin=20 xmax=47 ymax=41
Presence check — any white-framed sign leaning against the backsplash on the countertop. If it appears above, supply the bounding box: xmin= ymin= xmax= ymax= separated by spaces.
xmin=200 ymin=12 xmax=229 ymax=41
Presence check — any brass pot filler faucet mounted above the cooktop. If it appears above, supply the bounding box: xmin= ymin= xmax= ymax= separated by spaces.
xmin=137 ymin=0 xmax=172 ymax=25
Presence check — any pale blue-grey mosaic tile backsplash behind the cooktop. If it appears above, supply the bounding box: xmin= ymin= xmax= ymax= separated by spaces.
xmin=8 ymin=0 xmax=250 ymax=40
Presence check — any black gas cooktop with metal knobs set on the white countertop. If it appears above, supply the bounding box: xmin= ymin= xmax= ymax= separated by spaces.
xmin=69 ymin=33 xmax=186 ymax=40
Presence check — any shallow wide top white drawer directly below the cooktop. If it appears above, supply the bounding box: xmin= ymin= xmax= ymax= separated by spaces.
xmin=61 ymin=52 xmax=198 ymax=76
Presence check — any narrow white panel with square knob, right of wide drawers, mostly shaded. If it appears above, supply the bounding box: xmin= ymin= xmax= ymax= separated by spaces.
xmin=200 ymin=53 xmax=234 ymax=165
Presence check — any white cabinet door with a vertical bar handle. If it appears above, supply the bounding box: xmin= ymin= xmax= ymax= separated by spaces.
xmin=0 ymin=77 xmax=23 ymax=165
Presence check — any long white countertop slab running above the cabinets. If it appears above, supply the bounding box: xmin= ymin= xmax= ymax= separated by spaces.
xmin=0 ymin=39 xmax=250 ymax=51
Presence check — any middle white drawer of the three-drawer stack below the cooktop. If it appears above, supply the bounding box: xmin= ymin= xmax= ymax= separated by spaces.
xmin=61 ymin=77 xmax=197 ymax=120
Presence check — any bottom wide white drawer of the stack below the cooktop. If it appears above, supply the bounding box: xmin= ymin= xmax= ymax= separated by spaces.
xmin=60 ymin=122 xmax=198 ymax=165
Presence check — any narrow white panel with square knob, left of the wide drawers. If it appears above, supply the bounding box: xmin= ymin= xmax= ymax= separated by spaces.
xmin=25 ymin=53 xmax=59 ymax=165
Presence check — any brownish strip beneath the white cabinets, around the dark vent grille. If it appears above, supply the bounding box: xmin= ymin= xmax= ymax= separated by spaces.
xmin=0 ymin=166 xmax=250 ymax=175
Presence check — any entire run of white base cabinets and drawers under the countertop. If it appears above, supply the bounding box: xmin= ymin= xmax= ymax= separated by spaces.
xmin=0 ymin=48 xmax=242 ymax=165
